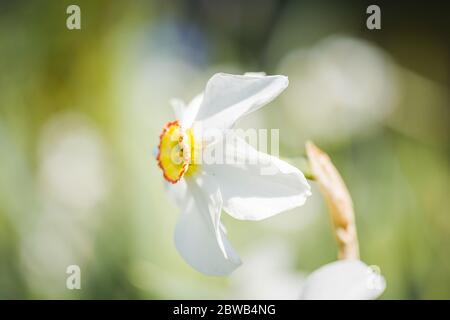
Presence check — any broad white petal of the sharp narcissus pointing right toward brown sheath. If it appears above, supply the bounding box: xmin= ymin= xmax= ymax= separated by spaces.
xmin=202 ymin=137 xmax=311 ymax=220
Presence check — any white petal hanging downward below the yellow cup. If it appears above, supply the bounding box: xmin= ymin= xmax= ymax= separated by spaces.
xmin=175 ymin=178 xmax=241 ymax=276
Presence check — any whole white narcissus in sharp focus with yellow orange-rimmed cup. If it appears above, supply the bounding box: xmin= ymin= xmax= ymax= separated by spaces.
xmin=157 ymin=73 xmax=310 ymax=275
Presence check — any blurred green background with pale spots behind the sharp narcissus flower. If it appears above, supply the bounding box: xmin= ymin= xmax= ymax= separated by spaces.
xmin=0 ymin=0 xmax=450 ymax=299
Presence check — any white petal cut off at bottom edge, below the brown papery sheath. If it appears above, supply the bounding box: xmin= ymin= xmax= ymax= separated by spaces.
xmin=302 ymin=260 xmax=386 ymax=300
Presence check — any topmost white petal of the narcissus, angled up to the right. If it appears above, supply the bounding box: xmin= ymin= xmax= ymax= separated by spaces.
xmin=195 ymin=73 xmax=289 ymax=129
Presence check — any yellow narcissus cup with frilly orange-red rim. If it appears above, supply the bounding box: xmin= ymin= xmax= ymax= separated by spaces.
xmin=157 ymin=121 xmax=196 ymax=183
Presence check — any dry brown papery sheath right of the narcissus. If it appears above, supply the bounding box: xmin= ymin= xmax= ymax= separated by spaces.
xmin=306 ymin=141 xmax=359 ymax=260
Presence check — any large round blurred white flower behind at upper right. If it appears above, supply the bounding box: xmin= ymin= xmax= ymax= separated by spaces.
xmin=279 ymin=36 xmax=399 ymax=145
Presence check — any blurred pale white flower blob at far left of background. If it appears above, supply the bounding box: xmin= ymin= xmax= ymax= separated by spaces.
xmin=39 ymin=113 xmax=108 ymax=212
